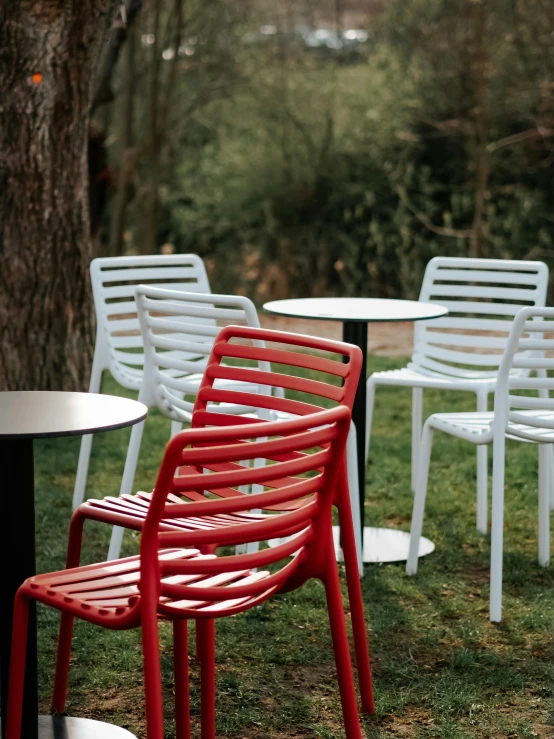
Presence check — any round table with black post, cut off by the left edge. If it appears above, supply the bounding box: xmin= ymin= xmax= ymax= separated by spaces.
xmin=0 ymin=391 xmax=148 ymax=739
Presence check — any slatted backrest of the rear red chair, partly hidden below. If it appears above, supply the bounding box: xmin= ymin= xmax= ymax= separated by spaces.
xmin=192 ymin=326 xmax=362 ymax=428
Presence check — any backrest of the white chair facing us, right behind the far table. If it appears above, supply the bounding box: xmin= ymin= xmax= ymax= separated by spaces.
xmin=409 ymin=257 xmax=548 ymax=379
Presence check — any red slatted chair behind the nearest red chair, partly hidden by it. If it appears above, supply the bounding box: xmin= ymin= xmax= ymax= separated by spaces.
xmin=67 ymin=326 xmax=375 ymax=713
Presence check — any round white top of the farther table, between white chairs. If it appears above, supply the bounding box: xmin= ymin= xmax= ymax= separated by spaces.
xmin=264 ymin=298 xmax=448 ymax=323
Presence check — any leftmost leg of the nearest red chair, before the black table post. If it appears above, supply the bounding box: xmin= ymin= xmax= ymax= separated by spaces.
xmin=5 ymin=593 xmax=29 ymax=739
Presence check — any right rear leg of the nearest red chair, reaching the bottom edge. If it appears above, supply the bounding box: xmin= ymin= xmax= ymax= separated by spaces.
xmin=324 ymin=553 xmax=363 ymax=739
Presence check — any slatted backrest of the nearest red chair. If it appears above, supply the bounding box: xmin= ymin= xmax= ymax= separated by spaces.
xmin=141 ymin=406 xmax=350 ymax=601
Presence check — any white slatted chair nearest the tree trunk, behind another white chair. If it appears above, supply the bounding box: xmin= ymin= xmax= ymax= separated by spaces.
xmin=73 ymin=254 xmax=210 ymax=508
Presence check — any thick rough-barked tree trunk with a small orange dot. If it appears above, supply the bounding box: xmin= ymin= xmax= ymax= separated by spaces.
xmin=0 ymin=0 xmax=118 ymax=390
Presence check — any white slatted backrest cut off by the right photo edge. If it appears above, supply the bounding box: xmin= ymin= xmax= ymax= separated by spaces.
xmin=494 ymin=308 xmax=554 ymax=441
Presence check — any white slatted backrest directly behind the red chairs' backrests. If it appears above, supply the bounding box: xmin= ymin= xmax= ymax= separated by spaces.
xmin=135 ymin=285 xmax=269 ymax=421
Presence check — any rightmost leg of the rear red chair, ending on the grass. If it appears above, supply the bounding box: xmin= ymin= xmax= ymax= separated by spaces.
xmin=339 ymin=500 xmax=375 ymax=714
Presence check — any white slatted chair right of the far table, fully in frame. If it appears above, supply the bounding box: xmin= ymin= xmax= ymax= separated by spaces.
xmin=366 ymin=257 xmax=548 ymax=533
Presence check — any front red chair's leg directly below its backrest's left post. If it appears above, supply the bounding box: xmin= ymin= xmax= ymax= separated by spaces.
xmin=142 ymin=609 xmax=164 ymax=739
